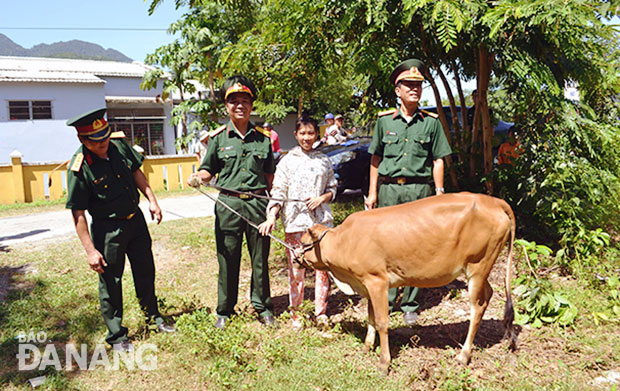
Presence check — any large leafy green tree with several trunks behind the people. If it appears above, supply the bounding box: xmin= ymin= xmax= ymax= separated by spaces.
xmin=147 ymin=0 xmax=620 ymax=258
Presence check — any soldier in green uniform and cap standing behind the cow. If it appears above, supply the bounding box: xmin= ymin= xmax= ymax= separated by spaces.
xmin=365 ymin=59 xmax=452 ymax=325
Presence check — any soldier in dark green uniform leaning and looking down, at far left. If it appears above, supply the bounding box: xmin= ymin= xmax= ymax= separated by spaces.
xmin=66 ymin=109 xmax=175 ymax=351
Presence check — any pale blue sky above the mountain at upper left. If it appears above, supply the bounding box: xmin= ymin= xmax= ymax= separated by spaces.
xmin=0 ymin=0 xmax=185 ymax=61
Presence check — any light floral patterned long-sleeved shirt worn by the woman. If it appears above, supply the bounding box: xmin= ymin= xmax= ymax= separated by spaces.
xmin=267 ymin=146 xmax=337 ymax=232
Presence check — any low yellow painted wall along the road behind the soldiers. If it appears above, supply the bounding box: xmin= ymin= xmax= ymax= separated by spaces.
xmin=0 ymin=155 xmax=199 ymax=204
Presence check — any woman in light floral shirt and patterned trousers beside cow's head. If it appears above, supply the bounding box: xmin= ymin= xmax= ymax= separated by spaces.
xmin=259 ymin=116 xmax=337 ymax=328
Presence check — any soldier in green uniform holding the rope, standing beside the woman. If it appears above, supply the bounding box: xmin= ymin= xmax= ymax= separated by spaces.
xmin=188 ymin=76 xmax=275 ymax=329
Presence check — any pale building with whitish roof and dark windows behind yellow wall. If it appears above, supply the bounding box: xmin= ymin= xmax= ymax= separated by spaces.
xmin=0 ymin=56 xmax=176 ymax=163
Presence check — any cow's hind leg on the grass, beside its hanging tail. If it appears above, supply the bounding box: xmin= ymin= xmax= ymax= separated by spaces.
xmin=456 ymin=277 xmax=493 ymax=365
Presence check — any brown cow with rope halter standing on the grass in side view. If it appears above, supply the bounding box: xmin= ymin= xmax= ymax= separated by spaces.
xmin=297 ymin=193 xmax=516 ymax=370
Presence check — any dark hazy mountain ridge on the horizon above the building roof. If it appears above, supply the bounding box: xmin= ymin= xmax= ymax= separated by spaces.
xmin=0 ymin=34 xmax=133 ymax=62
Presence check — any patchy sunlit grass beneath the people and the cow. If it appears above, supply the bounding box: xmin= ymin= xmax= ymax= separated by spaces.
xmin=0 ymin=201 xmax=620 ymax=391
